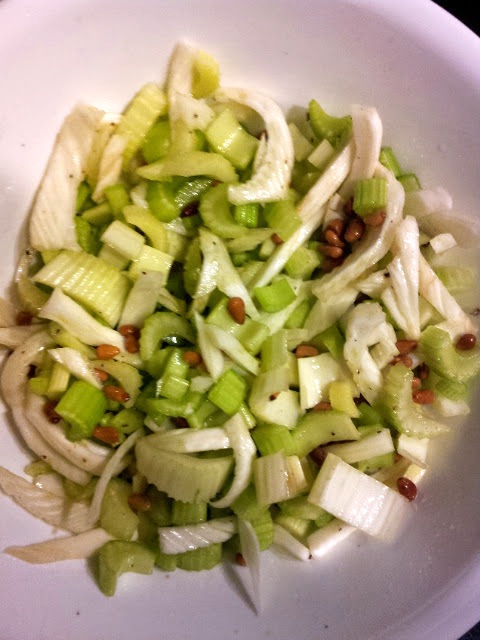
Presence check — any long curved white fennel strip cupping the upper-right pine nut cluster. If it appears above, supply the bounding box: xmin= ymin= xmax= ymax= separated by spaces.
xmin=312 ymin=163 xmax=405 ymax=300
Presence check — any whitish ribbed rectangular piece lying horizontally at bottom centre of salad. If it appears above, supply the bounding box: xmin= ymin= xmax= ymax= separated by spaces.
xmin=158 ymin=516 xmax=237 ymax=555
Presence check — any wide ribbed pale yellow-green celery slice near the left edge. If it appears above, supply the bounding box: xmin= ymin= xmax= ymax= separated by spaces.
xmin=34 ymin=250 xmax=130 ymax=327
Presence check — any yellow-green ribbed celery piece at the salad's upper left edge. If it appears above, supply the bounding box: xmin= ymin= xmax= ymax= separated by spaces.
xmin=115 ymin=83 xmax=167 ymax=169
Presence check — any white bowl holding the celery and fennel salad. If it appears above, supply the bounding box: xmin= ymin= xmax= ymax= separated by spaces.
xmin=0 ymin=0 xmax=480 ymax=640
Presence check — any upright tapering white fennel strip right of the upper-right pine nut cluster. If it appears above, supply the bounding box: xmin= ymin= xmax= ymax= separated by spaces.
xmin=381 ymin=216 xmax=420 ymax=340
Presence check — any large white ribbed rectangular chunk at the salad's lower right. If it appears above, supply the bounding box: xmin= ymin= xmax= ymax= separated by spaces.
xmin=308 ymin=453 xmax=406 ymax=537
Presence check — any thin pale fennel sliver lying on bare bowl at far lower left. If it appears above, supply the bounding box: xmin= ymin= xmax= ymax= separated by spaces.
xmin=4 ymin=528 xmax=113 ymax=564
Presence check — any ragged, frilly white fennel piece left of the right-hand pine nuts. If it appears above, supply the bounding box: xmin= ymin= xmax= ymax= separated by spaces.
xmin=343 ymin=302 xmax=396 ymax=403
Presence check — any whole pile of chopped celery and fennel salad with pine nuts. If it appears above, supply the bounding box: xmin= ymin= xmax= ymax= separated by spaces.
xmin=0 ymin=43 xmax=480 ymax=604
